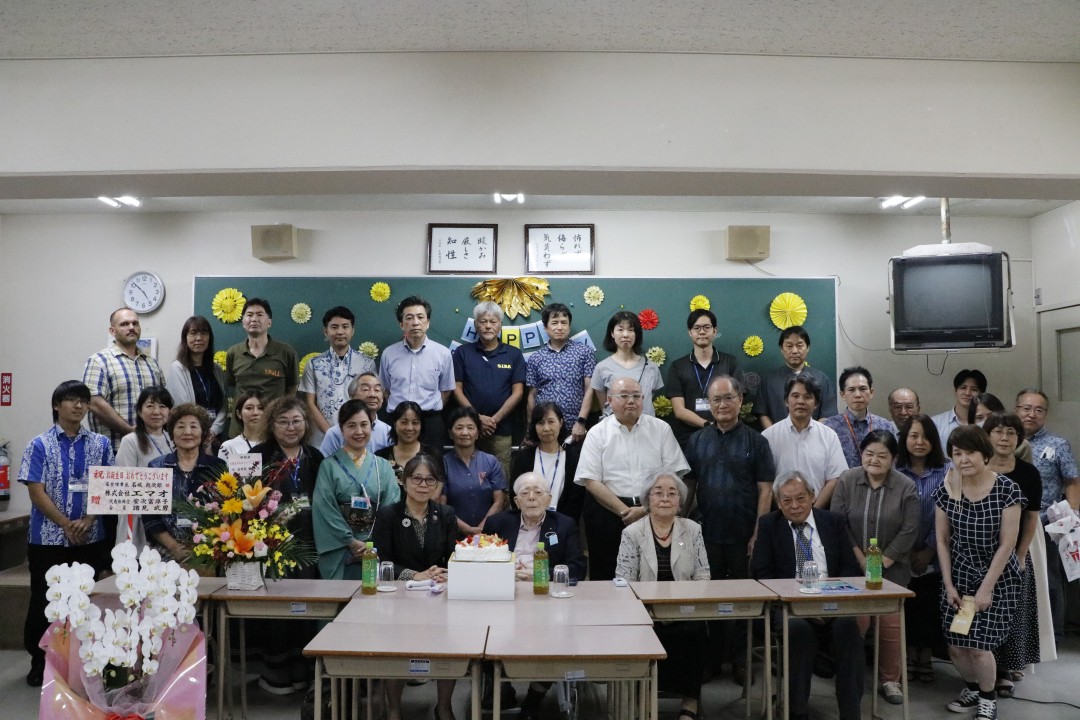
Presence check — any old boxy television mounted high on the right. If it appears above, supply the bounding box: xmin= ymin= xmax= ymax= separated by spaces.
xmin=889 ymin=253 xmax=1013 ymax=351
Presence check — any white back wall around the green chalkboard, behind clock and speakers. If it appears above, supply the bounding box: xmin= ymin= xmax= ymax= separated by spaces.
xmin=0 ymin=209 xmax=1036 ymax=508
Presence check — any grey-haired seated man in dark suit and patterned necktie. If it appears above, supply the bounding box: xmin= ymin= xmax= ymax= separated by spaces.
xmin=752 ymin=472 xmax=865 ymax=720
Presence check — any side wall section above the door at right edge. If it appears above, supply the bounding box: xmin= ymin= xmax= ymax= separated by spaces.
xmin=1031 ymin=202 xmax=1080 ymax=308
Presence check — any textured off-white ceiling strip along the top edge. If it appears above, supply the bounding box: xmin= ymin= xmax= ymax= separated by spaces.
xmin=0 ymin=0 xmax=1080 ymax=63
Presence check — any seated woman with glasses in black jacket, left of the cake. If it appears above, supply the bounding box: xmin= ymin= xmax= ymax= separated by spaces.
xmin=372 ymin=453 xmax=458 ymax=720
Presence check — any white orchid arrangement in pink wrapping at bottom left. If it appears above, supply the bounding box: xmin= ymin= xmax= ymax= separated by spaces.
xmin=39 ymin=542 xmax=206 ymax=720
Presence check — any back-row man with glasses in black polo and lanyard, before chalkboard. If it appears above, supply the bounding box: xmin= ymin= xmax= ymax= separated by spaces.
xmin=667 ymin=310 xmax=739 ymax=448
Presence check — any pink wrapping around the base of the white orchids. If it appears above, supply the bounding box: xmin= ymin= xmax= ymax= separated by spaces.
xmin=38 ymin=623 xmax=206 ymax=720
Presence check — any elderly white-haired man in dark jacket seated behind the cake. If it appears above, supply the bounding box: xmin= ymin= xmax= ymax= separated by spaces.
xmin=484 ymin=473 xmax=588 ymax=580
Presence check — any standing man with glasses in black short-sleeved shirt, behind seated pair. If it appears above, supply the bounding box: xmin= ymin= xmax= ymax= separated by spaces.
xmin=685 ymin=375 xmax=777 ymax=684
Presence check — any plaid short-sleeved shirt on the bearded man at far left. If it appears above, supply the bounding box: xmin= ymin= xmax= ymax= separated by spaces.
xmin=82 ymin=343 xmax=165 ymax=447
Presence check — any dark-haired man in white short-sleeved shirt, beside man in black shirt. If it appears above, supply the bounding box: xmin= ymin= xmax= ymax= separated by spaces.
xmin=761 ymin=373 xmax=848 ymax=510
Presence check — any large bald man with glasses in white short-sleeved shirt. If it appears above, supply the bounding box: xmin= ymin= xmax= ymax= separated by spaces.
xmin=573 ymin=378 xmax=686 ymax=580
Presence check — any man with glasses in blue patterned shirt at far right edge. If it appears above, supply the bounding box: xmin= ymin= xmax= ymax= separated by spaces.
xmin=1015 ymin=388 xmax=1080 ymax=641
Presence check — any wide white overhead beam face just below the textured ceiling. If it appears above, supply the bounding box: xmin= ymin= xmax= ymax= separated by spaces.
xmin=0 ymin=53 xmax=1080 ymax=179
